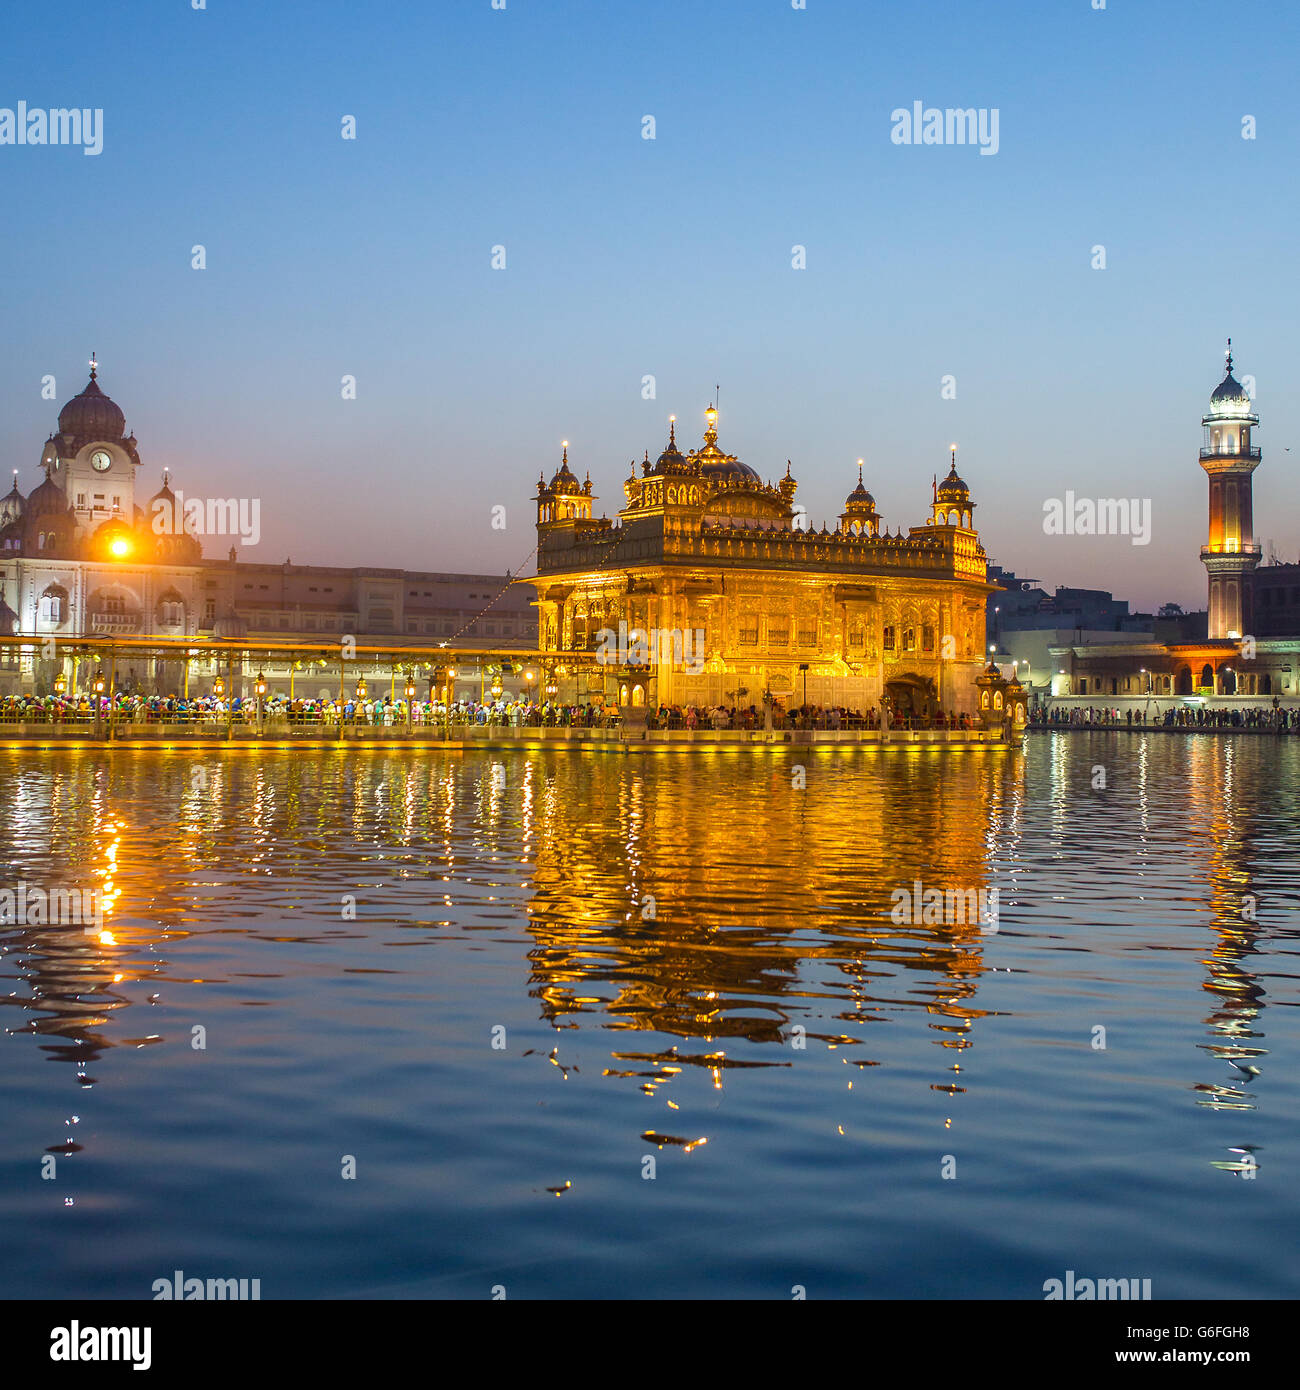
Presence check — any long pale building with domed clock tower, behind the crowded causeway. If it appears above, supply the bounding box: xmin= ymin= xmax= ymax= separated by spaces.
xmin=0 ymin=363 xmax=537 ymax=694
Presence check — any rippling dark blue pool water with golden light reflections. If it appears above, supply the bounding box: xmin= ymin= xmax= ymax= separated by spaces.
xmin=0 ymin=733 xmax=1300 ymax=1298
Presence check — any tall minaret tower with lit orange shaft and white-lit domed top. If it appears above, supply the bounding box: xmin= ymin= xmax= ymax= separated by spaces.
xmin=1201 ymin=338 xmax=1260 ymax=641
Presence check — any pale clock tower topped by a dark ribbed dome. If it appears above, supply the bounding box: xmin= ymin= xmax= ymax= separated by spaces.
xmin=40 ymin=354 xmax=140 ymax=538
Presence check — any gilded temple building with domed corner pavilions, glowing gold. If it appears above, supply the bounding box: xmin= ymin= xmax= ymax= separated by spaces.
xmin=530 ymin=406 xmax=994 ymax=714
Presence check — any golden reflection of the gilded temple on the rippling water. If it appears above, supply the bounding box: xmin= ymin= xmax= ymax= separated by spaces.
xmin=517 ymin=755 xmax=1023 ymax=1084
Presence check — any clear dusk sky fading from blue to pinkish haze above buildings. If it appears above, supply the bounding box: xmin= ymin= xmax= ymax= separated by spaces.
xmin=0 ymin=0 xmax=1300 ymax=607
